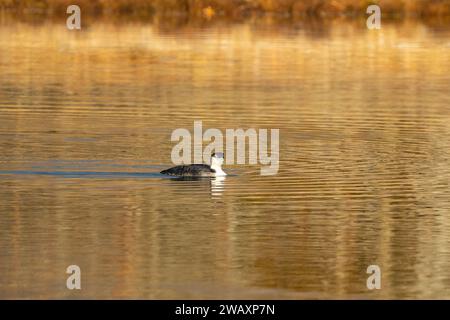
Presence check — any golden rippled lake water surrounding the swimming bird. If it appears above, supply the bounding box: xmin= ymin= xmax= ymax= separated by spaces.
xmin=0 ymin=16 xmax=450 ymax=298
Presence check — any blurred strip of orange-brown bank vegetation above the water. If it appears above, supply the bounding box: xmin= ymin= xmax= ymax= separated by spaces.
xmin=0 ymin=0 xmax=450 ymax=19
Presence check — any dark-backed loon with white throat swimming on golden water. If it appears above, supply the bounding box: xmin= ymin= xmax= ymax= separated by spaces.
xmin=161 ymin=152 xmax=227 ymax=177
